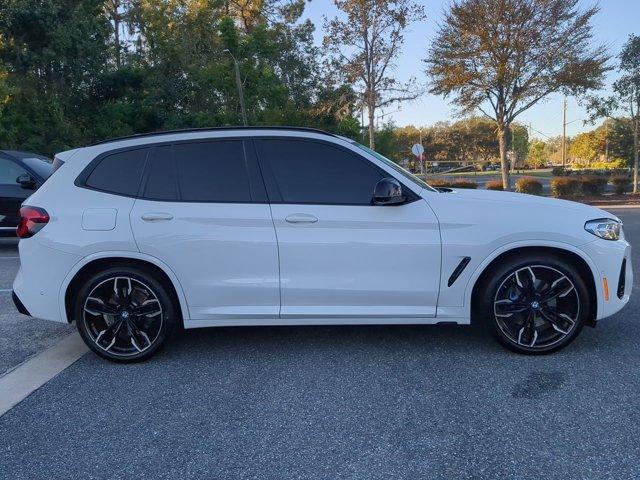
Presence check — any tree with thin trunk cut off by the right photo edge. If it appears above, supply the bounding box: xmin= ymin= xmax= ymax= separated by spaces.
xmin=587 ymin=35 xmax=640 ymax=193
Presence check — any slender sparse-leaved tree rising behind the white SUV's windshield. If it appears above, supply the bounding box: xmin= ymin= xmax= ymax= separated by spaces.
xmin=324 ymin=0 xmax=426 ymax=148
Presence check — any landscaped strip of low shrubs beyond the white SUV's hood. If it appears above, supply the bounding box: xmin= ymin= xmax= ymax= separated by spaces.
xmin=427 ymin=171 xmax=640 ymax=206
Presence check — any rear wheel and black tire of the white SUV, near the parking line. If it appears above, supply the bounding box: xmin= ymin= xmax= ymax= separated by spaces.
xmin=75 ymin=266 xmax=178 ymax=363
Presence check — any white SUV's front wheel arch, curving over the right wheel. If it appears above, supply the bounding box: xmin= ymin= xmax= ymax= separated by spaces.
xmin=467 ymin=244 xmax=602 ymax=325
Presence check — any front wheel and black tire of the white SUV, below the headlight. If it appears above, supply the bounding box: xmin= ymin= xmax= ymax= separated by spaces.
xmin=477 ymin=254 xmax=592 ymax=355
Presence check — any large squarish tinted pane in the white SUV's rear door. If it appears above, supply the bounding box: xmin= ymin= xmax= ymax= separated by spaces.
xmin=173 ymin=140 xmax=251 ymax=202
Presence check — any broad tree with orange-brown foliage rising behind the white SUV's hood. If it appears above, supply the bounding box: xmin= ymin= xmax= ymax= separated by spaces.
xmin=426 ymin=0 xmax=608 ymax=189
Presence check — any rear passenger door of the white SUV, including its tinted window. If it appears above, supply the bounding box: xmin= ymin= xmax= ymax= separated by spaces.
xmin=130 ymin=138 xmax=280 ymax=326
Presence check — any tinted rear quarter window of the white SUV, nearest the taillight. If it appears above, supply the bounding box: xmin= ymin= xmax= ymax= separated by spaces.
xmin=86 ymin=148 xmax=148 ymax=196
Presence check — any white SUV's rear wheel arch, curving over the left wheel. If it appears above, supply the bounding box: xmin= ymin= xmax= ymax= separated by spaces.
xmin=59 ymin=252 xmax=189 ymax=323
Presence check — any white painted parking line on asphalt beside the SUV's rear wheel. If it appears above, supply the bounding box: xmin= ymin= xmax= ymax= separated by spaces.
xmin=0 ymin=333 xmax=88 ymax=416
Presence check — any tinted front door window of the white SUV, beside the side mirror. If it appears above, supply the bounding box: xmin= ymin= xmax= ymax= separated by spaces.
xmin=258 ymin=139 xmax=383 ymax=205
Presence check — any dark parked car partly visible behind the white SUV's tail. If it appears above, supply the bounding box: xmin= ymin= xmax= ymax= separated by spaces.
xmin=0 ymin=150 xmax=53 ymax=236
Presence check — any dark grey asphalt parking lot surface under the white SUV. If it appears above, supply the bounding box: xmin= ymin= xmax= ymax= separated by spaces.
xmin=0 ymin=209 xmax=640 ymax=480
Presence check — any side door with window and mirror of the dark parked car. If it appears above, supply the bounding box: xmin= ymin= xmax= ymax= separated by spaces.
xmin=0 ymin=157 xmax=35 ymax=234
